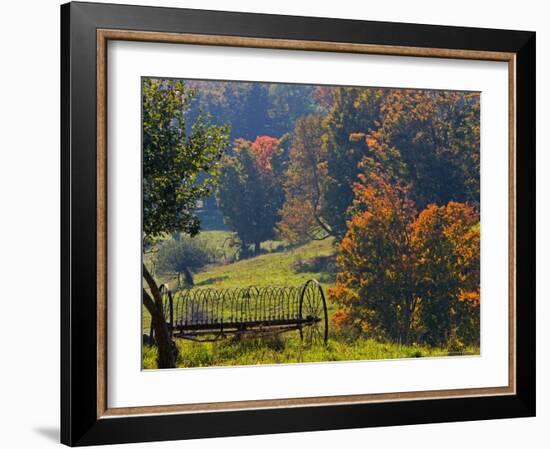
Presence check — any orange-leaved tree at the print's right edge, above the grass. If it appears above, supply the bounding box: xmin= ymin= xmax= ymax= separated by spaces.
xmin=411 ymin=202 xmax=480 ymax=345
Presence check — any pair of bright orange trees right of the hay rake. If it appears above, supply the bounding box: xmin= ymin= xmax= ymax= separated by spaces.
xmin=329 ymin=172 xmax=479 ymax=345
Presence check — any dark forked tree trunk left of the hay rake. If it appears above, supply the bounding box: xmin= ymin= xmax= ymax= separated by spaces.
xmin=143 ymin=264 xmax=176 ymax=368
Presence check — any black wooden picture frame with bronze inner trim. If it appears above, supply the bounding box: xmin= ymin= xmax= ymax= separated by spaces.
xmin=61 ymin=2 xmax=535 ymax=446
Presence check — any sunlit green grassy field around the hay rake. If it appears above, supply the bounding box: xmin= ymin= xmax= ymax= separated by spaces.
xmin=143 ymin=230 xmax=479 ymax=368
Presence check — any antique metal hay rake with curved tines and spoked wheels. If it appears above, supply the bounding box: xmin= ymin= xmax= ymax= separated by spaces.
xmin=156 ymin=279 xmax=328 ymax=344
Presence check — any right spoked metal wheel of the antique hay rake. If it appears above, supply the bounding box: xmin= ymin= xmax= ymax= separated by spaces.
xmin=300 ymin=279 xmax=328 ymax=346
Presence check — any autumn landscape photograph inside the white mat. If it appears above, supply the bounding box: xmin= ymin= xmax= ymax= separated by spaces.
xmin=141 ymin=76 xmax=482 ymax=370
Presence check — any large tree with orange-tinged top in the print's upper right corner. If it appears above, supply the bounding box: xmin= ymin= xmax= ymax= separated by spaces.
xmin=358 ymin=89 xmax=480 ymax=209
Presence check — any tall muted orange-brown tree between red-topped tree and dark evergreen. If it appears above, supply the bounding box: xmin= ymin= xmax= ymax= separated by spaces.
xmin=277 ymin=116 xmax=331 ymax=243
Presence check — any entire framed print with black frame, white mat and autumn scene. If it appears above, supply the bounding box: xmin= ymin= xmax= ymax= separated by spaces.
xmin=61 ymin=3 xmax=535 ymax=446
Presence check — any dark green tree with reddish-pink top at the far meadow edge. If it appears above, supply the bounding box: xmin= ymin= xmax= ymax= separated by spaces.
xmin=218 ymin=136 xmax=284 ymax=255
